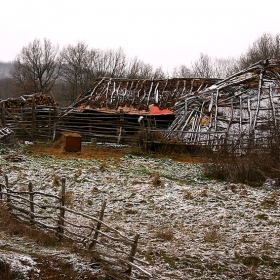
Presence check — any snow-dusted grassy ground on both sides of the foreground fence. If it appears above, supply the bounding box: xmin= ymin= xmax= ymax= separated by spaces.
xmin=0 ymin=143 xmax=280 ymax=280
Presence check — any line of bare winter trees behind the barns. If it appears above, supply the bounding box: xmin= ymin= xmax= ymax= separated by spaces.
xmin=0 ymin=33 xmax=280 ymax=105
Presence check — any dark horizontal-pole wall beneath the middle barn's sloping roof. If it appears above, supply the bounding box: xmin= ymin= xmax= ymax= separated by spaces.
xmin=56 ymin=109 xmax=174 ymax=145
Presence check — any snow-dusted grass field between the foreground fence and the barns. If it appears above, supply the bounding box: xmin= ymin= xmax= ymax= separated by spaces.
xmin=0 ymin=145 xmax=280 ymax=279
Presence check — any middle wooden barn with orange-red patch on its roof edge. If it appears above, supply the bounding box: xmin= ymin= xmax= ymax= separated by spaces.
xmin=57 ymin=78 xmax=218 ymax=144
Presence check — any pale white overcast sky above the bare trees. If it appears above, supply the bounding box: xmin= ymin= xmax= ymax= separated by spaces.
xmin=0 ymin=0 xmax=280 ymax=71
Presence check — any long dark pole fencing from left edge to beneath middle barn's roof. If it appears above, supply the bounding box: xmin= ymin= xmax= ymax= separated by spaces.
xmin=0 ymin=103 xmax=174 ymax=145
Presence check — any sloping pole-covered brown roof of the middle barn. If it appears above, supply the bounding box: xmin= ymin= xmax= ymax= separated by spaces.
xmin=65 ymin=78 xmax=218 ymax=114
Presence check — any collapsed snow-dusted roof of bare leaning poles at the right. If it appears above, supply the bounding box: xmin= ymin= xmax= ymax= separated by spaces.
xmin=166 ymin=59 xmax=280 ymax=149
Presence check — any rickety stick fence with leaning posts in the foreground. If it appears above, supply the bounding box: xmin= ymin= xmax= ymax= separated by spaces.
xmin=0 ymin=175 xmax=152 ymax=279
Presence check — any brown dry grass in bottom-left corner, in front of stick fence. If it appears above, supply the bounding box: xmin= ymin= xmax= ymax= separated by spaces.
xmin=0 ymin=202 xmax=114 ymax=280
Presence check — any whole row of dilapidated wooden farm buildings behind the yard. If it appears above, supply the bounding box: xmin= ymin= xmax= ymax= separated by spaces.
xmin=0 ymin=59 xmax=280 ymax=151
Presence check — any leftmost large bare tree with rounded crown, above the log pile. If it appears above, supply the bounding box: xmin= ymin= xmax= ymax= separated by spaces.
xmin=11 ymin=39 xmax=61 ymax=93
